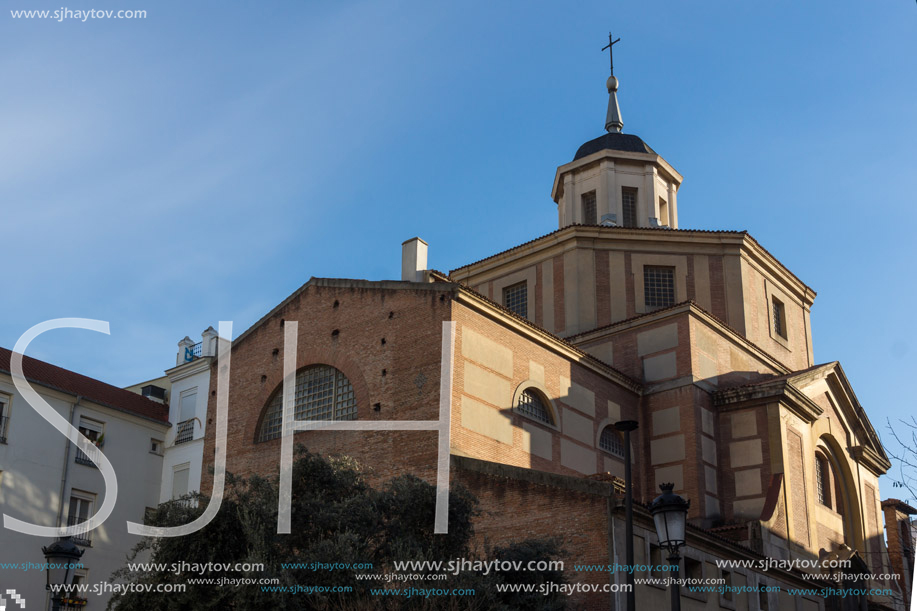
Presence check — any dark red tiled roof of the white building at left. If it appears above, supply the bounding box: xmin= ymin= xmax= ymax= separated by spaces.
xmin=0 ymin=348 xmax=169 ymax=424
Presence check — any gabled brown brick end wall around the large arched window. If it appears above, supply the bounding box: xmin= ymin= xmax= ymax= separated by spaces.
xmin=202 ymin=284 xmax=453 ymax=491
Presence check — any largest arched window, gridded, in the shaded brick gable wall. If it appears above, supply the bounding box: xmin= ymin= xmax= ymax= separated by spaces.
xmin=258 ymin=365 xmax=357 ymax=441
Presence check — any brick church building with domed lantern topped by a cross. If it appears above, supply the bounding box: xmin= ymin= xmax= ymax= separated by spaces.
xmin=203 ymin=47 xmax=913 ymax=611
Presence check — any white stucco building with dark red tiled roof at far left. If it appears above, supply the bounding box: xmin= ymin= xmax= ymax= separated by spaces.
xmin=0 ymin=348 xmax=174 ymax=609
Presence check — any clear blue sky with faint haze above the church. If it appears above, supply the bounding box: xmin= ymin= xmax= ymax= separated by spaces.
xmin=0 ymin=0 xmax=917 ymax=495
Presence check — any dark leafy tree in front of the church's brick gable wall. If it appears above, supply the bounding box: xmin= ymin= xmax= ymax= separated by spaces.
xmin=108 ymin=447 xmax=566 ymax=611
